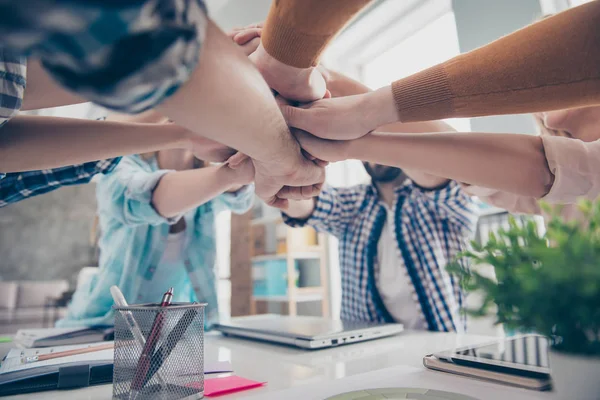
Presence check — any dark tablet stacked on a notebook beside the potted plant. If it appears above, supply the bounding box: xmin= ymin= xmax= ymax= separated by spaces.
xmin=423 ymin=335 xmax=551 ymax=390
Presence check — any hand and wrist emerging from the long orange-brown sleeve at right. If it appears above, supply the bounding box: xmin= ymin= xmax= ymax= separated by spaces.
xmin=280 ymin=87 xmax=398 ymax=140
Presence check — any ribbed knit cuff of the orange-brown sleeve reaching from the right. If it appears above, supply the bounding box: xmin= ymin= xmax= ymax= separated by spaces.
xmin=392 ymin=64 xmax=454 ymax=122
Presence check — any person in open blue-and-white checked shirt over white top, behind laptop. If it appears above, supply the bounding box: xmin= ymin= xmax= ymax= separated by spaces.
xmin=276 ymin=73 xmax=477 ymax=332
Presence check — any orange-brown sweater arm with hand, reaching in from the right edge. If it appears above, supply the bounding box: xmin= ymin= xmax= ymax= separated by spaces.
xmin=283 ymin=1 xmax=600 ymax=140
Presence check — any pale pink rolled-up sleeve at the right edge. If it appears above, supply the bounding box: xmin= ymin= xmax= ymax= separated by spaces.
xmin=542 ymin=136 xmax=600 ymax=204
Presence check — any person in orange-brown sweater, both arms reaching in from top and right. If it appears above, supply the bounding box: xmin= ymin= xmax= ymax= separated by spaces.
xmin=252 ymin=0 xmax=600 ymax=115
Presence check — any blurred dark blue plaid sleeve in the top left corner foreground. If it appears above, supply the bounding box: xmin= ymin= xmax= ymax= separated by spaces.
xmin=0 ymin=0 xmax=207 ymax=113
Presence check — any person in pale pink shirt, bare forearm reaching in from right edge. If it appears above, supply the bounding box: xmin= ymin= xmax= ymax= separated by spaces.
xmin=268 ymin=69 xmax=600 ymax=213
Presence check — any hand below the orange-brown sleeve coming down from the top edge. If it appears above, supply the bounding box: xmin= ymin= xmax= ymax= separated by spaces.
xmin=249 ymin=43 xmax=326 ymax=102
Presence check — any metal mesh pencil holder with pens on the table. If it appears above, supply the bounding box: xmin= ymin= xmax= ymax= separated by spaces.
xmin=113 ymin=303 xmax=206 ymax=400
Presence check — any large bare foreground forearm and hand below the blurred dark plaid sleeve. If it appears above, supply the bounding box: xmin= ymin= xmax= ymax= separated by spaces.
xmin=158 ymin=22 xmax=324 ymax=207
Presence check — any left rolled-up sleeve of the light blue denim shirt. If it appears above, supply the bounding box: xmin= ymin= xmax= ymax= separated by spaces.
xmin=96 ymin=156 xmax=179 ymax=226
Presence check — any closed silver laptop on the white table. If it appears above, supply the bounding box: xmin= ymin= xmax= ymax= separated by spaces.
xmin=214 ymin=314 xmax=404 ymax=349
